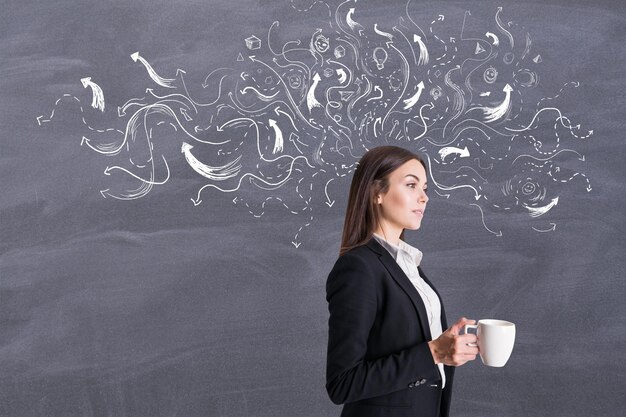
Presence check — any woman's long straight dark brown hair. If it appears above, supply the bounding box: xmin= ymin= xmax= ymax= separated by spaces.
xmin=339 ymin=146 xmax=426 ymax=256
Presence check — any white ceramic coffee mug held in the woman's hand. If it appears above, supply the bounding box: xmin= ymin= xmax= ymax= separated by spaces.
xmin=464 ymin=319 xmax=515 ymax=367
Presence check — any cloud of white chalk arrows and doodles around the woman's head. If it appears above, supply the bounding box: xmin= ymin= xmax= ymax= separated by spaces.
xmin=37 ymin=0 xmax=593 ymax=244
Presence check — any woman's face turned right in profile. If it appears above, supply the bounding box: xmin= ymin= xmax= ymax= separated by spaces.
xmin=377 ymin=159 xmax=428 ymax=237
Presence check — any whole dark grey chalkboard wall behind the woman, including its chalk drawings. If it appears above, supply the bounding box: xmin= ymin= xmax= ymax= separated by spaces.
xmin=0 ymin=0 xmax=626 ymax=417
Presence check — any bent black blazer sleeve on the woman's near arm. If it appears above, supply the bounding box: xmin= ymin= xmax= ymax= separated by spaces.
xmin=326 ymin=254 xmax=439 ymax=404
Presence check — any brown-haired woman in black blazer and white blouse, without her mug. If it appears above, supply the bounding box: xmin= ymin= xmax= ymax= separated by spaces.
xmin=326 ymin=146 xmax=478 ymax=417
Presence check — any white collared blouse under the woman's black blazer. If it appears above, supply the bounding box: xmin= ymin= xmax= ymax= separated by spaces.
xmin=374 ymin=233 xmax=446 ymax=389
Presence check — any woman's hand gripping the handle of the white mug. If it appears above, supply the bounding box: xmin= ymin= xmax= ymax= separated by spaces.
xmin=428 ymin=317 xmax=478 ymax=366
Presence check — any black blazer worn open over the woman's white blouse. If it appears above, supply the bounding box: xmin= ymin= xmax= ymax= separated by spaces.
xmin=326 ymin=238 xmax=454 ymax=417
